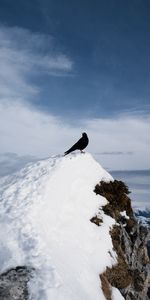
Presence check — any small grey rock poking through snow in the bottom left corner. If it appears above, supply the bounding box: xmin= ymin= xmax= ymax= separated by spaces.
xmin=0 ymin=267 xmax=32 ymax=300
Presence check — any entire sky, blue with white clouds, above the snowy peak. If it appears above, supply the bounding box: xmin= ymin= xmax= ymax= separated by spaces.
xmin=0 ymin=0 xmax=150 ymax=175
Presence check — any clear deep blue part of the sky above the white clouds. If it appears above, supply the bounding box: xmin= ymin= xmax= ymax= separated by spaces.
xmin=0 ymin=0 xmax=150 ymax=118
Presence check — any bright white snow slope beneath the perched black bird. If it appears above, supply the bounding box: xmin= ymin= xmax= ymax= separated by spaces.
xmin=0 ymin=154 xmax=123 ymax=300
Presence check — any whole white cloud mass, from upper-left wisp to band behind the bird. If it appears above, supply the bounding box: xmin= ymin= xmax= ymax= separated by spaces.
xmin=0 ymin=27 xmax=150 ymax=173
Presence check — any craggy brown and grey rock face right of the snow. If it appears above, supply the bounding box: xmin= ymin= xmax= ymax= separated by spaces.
xmin=94 ymin=180 xmax=150 ymax=300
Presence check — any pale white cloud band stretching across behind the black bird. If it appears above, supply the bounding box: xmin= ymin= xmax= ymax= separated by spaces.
xmin=0 ymin=102 xmax=150 ymax=170
